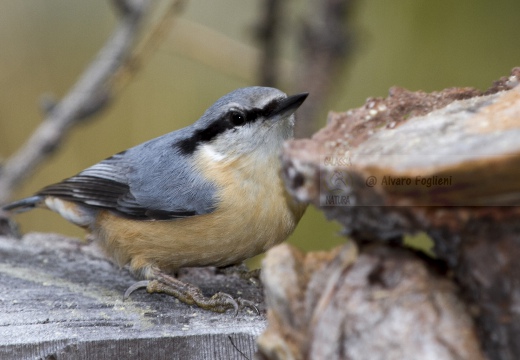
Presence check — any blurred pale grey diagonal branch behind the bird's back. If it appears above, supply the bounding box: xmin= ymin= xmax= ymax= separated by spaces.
xmin=0 ymin=0 xmax=183 ymax=204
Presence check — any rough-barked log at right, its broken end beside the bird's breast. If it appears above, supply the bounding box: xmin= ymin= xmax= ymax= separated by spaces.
xmin=282 ymin=68 xmax=520 ymax=359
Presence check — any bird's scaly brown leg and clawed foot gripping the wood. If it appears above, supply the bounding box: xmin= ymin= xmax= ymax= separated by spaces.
xmin=124 ymin=271 xmax=258 ymax=315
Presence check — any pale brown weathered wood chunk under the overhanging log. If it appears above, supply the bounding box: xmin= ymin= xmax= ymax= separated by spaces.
xmin=258 ymin=243 xmax=484 ymax=360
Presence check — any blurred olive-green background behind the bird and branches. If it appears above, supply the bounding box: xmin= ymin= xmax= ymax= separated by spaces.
xmin=0 ymin=0 xmax=520 ymax=264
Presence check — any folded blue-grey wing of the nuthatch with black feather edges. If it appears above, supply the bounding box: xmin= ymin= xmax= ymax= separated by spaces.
xmin=37 ymin=138 xmax=217 ymax=220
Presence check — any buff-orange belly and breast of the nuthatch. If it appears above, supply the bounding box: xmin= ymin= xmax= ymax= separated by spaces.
xmin=95 ymin=173 xmax=305 ymax=275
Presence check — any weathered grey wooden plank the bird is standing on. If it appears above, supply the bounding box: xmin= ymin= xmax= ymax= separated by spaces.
xmin=0 ymin=234 xmax=265 ymax=359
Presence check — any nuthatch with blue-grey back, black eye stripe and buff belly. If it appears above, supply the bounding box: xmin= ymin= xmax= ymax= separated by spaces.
xmin=4 ymin=87 xmax=308 ymax=312
